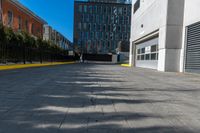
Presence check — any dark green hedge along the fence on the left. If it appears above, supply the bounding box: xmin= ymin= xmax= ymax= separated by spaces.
xmin=0 ymin=24 xmax=68 ymax=63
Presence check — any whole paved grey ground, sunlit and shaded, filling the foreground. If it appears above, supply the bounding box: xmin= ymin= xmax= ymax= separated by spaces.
xmin=0 ymin=63 xmax=200 ymax=133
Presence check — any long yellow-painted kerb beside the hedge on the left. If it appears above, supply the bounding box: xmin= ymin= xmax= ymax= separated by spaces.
xmin=0 ymin=61 xmax=75 ymax=71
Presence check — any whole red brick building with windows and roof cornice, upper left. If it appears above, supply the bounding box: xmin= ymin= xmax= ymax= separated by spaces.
xmin=0 ymin=0 xmax=46 ymax=37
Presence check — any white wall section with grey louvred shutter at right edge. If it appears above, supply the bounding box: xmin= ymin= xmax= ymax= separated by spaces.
xmin=180 ymin=0 xmax=200 ymax=73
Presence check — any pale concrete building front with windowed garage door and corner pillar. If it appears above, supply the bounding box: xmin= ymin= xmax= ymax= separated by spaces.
xmin=130 ymin=0 xmax=185 ymax=72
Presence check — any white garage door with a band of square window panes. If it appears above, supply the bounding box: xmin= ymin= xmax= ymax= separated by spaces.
xmin=135 ymin=38 xmax=158 ymax=69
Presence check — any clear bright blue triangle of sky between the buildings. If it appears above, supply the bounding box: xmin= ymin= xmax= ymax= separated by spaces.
xmin=19 ymin=0 xmax=74 ymax=41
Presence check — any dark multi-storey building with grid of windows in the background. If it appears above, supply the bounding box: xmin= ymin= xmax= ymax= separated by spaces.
xmin=74 ymin=0 xmax=131 ymax=54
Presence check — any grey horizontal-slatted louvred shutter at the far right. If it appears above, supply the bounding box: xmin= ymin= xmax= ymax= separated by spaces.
xmin=185 ymin=23 xmax=200 ymax=72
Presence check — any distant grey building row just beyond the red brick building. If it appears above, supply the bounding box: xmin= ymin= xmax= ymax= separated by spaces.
xmin=43 ymin=25 xmax=72 ymax=50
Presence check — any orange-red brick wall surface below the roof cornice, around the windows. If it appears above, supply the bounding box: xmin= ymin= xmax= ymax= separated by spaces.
xmin=2 ymin=0 xmax=43 ymax=37
